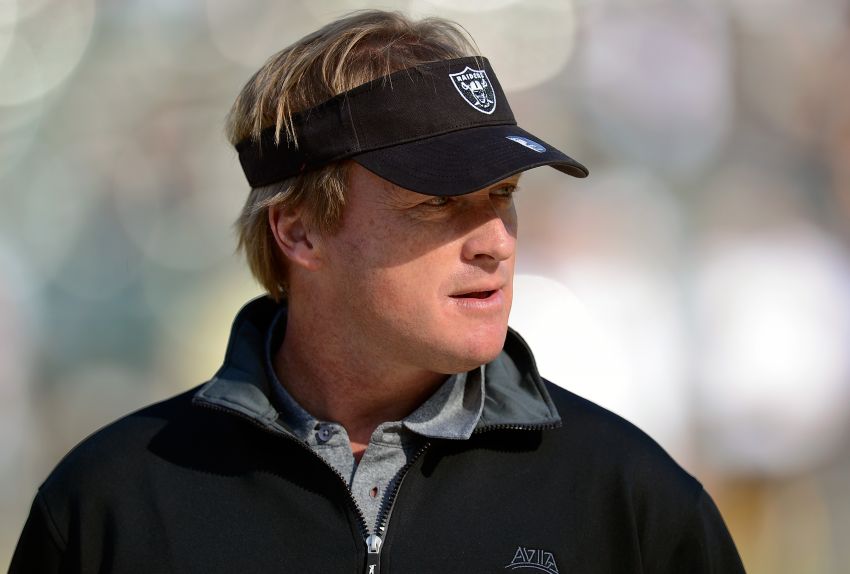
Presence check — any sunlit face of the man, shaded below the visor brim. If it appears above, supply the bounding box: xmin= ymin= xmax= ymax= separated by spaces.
xmin=322 ymin=164 xmax=519 ymax=373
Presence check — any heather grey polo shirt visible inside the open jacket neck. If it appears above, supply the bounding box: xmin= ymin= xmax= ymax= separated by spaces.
xmin=266 ymin=307 xmax=484 ymax=532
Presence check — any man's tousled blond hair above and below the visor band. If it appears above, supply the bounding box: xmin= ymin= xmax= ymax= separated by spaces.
xmin=227 ymin=10 xmax=478 ymax=300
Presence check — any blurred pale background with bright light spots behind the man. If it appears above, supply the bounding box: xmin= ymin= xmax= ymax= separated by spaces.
xmin=0 ymin=0 xmax=850 ymax=574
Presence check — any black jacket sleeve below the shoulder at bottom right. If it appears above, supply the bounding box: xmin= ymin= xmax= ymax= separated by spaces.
xmin=649 ymin=489 xmax=744 ymax=574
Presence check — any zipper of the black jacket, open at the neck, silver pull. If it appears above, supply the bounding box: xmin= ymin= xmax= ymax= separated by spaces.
xmin=196 ymin=402 xmax=561 ymax=574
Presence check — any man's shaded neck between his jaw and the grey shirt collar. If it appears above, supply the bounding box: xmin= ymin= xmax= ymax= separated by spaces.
xmin=273 ymin=307 xmax=447 ymax=460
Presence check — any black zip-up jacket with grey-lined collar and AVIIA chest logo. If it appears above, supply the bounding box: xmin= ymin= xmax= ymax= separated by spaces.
xmin=10 ymin=299 xmax=743 ymax=574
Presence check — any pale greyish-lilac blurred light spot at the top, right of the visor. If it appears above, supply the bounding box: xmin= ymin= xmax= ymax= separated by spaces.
xmin=577 ymin=2 xmax=733 ymax=173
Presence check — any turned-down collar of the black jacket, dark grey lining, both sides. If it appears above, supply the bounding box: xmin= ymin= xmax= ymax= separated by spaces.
xmin=192 ymin=296 xmax=561 ymax=432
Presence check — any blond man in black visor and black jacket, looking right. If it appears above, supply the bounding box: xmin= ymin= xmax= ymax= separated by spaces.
xmin=11 ymin=11 xmax=743 ymax=574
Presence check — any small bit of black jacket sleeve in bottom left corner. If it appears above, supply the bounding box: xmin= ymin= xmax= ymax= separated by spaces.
xmin=9 ymin=493 xmax=67 ymax=574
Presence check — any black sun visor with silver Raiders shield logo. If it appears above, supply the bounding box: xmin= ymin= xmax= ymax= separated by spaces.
xmin=236 ymin=57 xmax=587 ymax=195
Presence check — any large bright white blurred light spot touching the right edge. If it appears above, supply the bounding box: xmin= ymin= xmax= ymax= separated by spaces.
xmin=696 ymin=228 xmax=850 ymax=476
